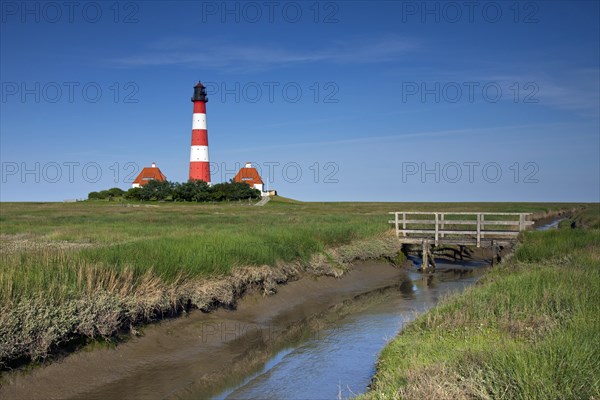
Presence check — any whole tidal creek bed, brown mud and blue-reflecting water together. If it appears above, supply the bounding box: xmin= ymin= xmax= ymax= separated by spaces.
xmin=0 ymin=260 xmax=482 ymax=399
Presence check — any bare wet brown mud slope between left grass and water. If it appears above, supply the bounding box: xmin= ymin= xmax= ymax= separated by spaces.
xmin=0 ymin=261 xmax=408 ymax=399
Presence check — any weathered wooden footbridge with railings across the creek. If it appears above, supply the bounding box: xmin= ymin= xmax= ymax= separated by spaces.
xmin=389 ymin=211 xmax=533 ymax=271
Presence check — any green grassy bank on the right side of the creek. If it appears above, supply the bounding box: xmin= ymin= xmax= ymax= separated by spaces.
xmin=363 ymin=205 xmax=600 ymax=399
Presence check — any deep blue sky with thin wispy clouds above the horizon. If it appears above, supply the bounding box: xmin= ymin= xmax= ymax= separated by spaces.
xmin=0 ymin=1 xmax=600 ymax=201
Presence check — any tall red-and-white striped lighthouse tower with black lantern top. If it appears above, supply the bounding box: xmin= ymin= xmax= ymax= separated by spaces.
xmin=190 ymin=82 xmax=210 ymax=183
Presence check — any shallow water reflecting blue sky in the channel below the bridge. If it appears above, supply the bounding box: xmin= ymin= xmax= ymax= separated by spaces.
xmin=211 ymin=263 xmax=482 ymax=399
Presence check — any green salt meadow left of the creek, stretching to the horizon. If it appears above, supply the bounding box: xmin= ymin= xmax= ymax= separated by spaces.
xmin=0 ymin=200 xmax=576 ymax=366
